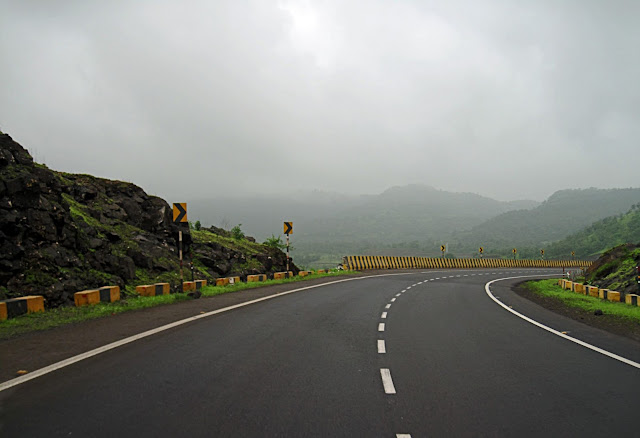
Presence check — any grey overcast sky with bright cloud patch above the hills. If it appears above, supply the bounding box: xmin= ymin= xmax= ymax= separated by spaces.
xmin=0 ymin=0 xmax=640 ymax=202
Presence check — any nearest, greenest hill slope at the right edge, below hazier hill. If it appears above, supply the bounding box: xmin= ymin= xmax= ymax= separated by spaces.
xmin=546 ymin=204 xmax=640 ymax=258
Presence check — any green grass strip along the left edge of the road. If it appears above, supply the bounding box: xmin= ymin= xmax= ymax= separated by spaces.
xmin=0 ymin=271 xmax=356 ymax=340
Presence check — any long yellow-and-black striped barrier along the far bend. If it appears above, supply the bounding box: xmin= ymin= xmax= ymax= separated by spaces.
xmin=342 ymin=256 xmax=592 ymax=271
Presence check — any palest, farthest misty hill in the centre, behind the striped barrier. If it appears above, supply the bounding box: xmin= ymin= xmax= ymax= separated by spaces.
xmin=189 ymin=185 xmax=539 ymax=264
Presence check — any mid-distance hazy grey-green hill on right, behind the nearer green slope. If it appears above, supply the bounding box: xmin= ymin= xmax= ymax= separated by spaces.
xmin=455 ymin=188 xmax=640 ymax=250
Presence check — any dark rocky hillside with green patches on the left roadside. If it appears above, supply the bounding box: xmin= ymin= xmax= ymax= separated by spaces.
xmin=0 ymin=134 xmax=297 ymax=307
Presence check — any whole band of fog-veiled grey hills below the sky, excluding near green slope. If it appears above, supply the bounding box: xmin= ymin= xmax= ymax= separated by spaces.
xmin=189 ymin=184 xmax=640 ymax=264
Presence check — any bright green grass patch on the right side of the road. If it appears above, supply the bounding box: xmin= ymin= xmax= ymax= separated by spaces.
xmin=525 ymin=279 xmax=640 ymax=323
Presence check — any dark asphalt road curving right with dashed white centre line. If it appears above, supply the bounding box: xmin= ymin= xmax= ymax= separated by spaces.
xmin=0 ymin=269 xmax=640 ymax=438
